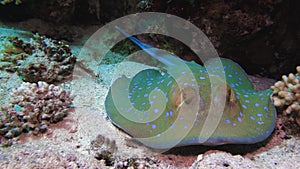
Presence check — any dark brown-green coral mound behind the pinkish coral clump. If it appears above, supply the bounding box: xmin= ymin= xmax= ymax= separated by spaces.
xmin=0 ymin=35 xmax=76 ymax=83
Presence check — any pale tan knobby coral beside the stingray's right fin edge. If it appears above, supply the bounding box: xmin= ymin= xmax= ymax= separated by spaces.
xmin=271 ymin=66 xmax=300 ymax=126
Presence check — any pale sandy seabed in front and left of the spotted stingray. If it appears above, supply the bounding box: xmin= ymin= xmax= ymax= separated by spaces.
xmin=0 ymin=62 xmax=300 ymax=168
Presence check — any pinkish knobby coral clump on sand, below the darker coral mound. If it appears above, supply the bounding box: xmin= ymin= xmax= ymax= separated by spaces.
xmin=0 ymin=81 xmax=74 ymax=139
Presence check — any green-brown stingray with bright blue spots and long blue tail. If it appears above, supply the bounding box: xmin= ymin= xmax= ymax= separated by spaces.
xmin=105 ymin=27 xmax=276 ymax=149
